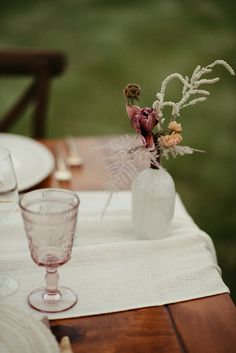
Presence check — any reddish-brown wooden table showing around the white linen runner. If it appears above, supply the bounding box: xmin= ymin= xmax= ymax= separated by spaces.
xmin=37 ymin=137 xmax=236 ymax=353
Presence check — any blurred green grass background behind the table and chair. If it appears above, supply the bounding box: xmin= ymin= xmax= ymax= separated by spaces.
xmin=0 ymin=0 xmax=236 ymax=298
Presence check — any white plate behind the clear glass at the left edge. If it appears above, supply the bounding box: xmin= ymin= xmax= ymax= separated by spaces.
xmin=0 ymin=133 xmax=54 ymax=191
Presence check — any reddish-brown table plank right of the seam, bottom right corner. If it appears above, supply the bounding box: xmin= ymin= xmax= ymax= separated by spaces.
xmin=167 ymin=294 xmax=236 ymax=353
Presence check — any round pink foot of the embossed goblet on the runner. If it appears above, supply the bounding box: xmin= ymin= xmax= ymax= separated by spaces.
xmin=28 ymin=287 xmax=78 ymax=313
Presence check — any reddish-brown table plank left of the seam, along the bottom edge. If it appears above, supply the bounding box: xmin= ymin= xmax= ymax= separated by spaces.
xmin=51 ymin=307 xmax=182 ymax=353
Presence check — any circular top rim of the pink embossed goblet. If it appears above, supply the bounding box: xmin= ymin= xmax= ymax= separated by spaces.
xmin=19 ymin=188 xmax=80 ymax=215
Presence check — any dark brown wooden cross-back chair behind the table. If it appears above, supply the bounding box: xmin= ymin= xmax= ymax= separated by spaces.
xmin=0 ymin=50 xmax=66 ymax=138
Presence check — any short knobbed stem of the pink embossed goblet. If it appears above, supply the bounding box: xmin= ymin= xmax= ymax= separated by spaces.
xmin=43 ymin=267 xmax=61 ymax=301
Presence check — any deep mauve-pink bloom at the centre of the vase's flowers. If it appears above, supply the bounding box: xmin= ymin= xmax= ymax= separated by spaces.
xmin=126 ymin=104 xmax=159 ymax=150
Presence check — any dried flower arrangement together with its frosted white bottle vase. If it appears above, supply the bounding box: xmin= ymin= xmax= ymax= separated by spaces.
xmin=101 ymin=60 xmax=235 ymax=239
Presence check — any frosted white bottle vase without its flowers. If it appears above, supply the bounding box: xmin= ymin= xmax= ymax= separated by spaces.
xmin=131 ymin=168 xmax=175 ymax=239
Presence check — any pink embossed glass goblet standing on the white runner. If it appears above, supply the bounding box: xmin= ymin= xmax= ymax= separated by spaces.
xmin=19 ymin=189 xmax=80 ymax=313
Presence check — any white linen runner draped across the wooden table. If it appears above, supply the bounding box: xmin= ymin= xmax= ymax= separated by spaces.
xmin=0 ymin=191 xmax=229 ymax=319
